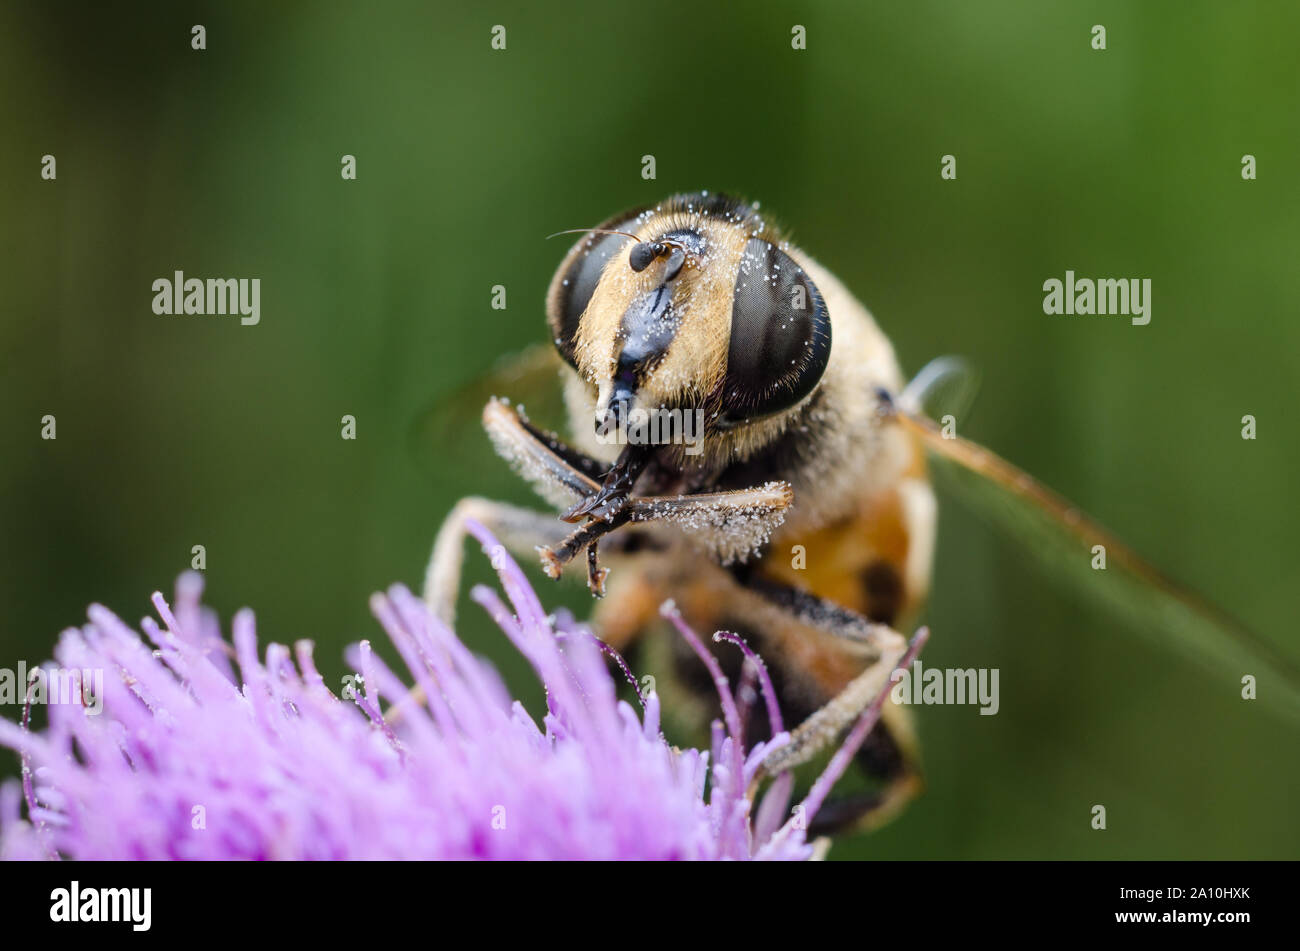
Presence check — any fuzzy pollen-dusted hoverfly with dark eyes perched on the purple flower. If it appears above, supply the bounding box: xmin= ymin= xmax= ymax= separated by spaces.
xmin=425 ymin=192 xmax=1300 ymax=826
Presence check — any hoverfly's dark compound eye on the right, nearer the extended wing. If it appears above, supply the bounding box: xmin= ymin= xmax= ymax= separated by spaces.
xmin=723 ymin=238 xmax=831 ymax=422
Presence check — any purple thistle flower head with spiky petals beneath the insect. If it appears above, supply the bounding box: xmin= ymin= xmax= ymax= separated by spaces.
xmin=0 ymin=525 xmax=919 ymax=859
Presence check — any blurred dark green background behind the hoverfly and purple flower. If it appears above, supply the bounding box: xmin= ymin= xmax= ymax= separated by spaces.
xmin=0 ymin=0 xmax=1300 ymax=859
